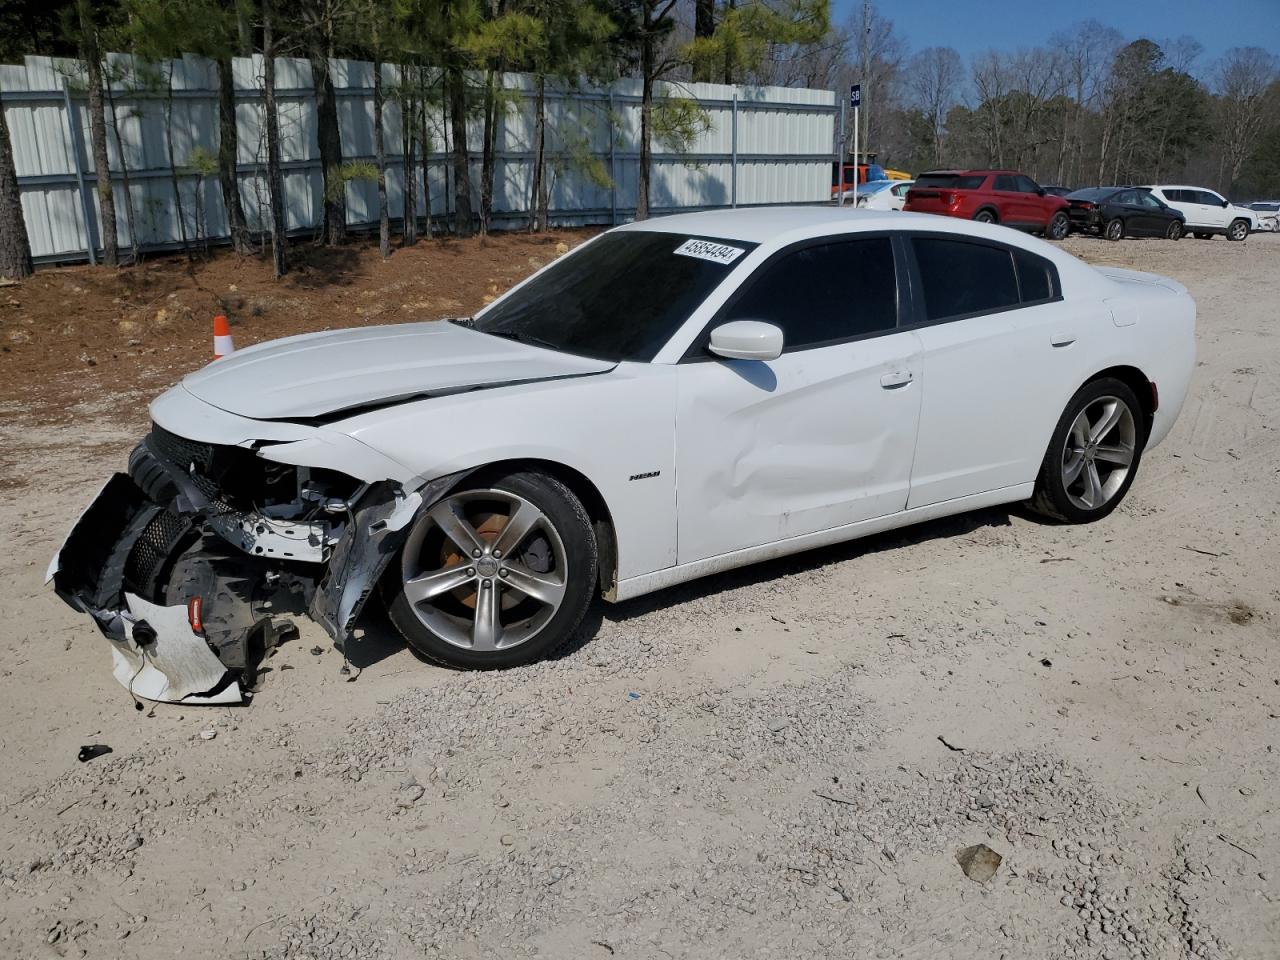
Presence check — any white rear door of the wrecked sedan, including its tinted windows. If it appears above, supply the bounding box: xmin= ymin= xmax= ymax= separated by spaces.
xmin=908 ymin=234 xmax=1085 ymax=508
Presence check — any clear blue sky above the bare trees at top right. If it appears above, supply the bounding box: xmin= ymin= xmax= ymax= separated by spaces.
xmin=832 ymin=0 xmax=1280 ymax=72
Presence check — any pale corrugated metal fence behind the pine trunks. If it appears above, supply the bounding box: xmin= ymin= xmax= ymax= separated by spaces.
xmin=0 ymin=54 xmax=838 ymax=259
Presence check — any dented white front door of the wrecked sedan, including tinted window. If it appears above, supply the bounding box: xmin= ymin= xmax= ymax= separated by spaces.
xmin=676 ymin=236 xmax=920 ymax=563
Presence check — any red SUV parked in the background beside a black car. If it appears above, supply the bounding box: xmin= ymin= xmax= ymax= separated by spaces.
xmin=902 ymin=170 xmax=1071 ymax=239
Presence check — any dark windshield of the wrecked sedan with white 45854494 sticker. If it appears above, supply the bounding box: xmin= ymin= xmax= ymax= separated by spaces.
xmin=467 ymin=230 xmax=756 ymax=362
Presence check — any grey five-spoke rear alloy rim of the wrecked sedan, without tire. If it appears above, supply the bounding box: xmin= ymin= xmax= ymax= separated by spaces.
xmin=1062 ymin=397 xmax=1138 ymax=509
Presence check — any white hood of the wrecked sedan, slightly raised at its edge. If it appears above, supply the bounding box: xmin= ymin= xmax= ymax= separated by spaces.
xmin=183 ymin=321 xmax=614 ymax=420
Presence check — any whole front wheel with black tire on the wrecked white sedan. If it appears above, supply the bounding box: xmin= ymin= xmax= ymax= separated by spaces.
xmin=383 ymin=471 xmax=598 ymax=669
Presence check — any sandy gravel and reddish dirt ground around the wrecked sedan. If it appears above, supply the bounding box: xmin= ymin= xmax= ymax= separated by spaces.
xmin=0 ymin=234 xmax=1280 ymax=960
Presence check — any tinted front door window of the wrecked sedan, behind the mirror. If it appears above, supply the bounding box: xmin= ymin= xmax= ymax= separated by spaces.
xmin=724 ymin=237 xmax=897 ymax=351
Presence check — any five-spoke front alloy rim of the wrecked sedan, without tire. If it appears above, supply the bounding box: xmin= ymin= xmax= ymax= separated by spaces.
xmin=401 ymin=489 xmax=568 ymax=652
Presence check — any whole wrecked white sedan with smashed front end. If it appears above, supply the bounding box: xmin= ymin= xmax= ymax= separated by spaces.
xmin=51 ymin=207 xmax=1196 ymax=699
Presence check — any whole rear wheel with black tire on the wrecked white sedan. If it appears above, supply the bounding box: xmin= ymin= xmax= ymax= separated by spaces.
xmin=1029 ymin=376 xmax=1147 ymax=524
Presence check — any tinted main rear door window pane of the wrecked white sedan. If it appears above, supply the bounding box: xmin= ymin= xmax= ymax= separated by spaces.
xmin=911 ymin=237 xmax=1019 ymax=321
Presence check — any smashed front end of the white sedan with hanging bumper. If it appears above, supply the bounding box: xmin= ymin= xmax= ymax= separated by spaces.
xmin=49 ymin=425 xmax=422 ymax=703
